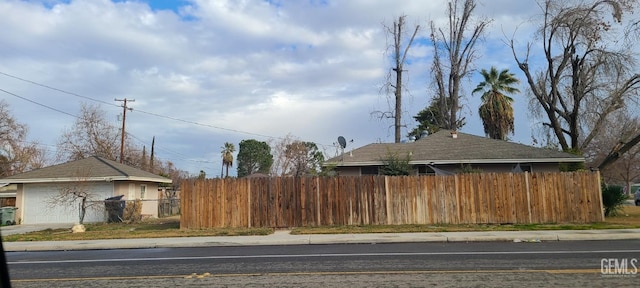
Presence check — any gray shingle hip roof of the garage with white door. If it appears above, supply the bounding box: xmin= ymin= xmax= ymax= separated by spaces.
xmin=0 ymin=156 xmax=171 ymax=184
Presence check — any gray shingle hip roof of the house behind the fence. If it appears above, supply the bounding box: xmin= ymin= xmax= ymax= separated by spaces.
xmin=325 ymin=130 xmax=584 ymax=166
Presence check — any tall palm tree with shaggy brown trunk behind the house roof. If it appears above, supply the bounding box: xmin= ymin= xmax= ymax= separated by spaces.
xmin=472 ymin=67 xmax=520 ymax=140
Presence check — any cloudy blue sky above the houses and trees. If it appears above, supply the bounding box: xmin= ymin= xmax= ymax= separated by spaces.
xmin=0 ymin=0 xmax=540 ymax=177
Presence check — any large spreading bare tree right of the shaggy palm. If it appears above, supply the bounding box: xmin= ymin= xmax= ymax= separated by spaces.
xmin=511 ymin=0 xmax=640 ymax=169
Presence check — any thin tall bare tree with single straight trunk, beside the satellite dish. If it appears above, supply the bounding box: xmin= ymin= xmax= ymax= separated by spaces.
xmin=372 ymin=15 xmax=420 ymax=143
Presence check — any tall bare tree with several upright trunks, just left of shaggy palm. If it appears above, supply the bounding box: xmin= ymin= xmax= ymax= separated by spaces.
xmin=430 ymin=0 xmax=489 ymax=130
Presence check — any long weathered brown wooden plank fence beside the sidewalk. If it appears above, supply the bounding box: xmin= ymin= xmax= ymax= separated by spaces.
xmin=180 ymin=172 xmax=604 ymax=229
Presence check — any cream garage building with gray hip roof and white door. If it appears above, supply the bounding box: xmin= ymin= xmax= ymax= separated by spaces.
xmin=0 ymin=156 xmax=171 ymax=224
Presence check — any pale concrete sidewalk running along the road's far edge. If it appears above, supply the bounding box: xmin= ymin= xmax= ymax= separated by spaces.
xmin=3 ymin=229 xmax=640 ymax=251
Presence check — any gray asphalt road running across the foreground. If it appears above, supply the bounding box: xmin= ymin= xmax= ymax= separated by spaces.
xmin=7 ymin=240 xmax=640 ymax=287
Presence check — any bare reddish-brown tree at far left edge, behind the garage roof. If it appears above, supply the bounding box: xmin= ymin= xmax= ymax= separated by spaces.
xmin=0 ymin=100 xmax=46 ymax=177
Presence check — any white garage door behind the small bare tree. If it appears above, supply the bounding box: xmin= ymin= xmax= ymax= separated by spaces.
xmin=22 ymin=182 xmax=113 ymax=224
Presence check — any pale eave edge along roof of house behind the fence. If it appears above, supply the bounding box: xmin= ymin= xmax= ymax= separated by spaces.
xmin=322 ymin=157 xmax=585 ymax=167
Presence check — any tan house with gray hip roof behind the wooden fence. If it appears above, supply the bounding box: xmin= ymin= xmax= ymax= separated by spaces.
xmin=323 ymin=130 xmax=585 ymax=176
